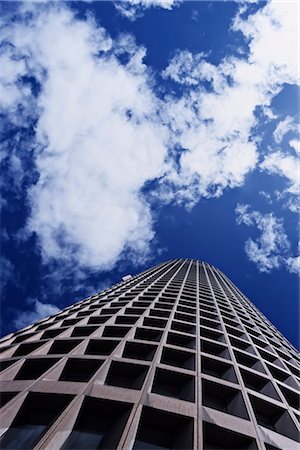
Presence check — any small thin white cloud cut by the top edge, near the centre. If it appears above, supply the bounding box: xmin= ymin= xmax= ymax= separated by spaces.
xmin=114 ymin=0 xmax=181 ymax=21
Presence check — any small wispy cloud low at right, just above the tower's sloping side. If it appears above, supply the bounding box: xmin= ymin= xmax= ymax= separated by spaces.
xmin=235 ymin=204 xmax=299 ymax=272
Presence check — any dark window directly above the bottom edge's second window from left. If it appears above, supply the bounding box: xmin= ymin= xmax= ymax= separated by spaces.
xmin=105 ymin=361 xmax=148 ymax=389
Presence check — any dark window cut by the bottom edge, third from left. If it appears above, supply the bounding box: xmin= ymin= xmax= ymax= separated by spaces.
xmin=133 ymin=407 xmax=194 ymax=450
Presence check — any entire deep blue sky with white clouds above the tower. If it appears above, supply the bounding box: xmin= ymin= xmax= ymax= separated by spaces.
xmin=0 ymin=0 xmax=299 ymax=347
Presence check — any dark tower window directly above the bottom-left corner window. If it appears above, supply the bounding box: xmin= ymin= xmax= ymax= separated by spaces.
xmin=59 ymin=358 xmax=104 ymax=382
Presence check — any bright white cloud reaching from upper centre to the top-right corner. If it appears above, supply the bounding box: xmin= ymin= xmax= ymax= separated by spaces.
xmin=159 ymin=2 xmax=298 ymax=202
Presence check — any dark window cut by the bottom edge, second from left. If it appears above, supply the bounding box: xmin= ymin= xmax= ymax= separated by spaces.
xmin=61 ymin=397 xmax=132 ymax=450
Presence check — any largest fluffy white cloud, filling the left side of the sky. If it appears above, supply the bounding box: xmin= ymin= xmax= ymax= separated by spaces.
xmin=2 ymin=5 xmax=166 ymax=269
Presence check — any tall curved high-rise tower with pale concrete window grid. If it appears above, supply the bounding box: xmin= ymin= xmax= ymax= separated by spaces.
xmin=0 ymin=259 xmax=299 ymax=450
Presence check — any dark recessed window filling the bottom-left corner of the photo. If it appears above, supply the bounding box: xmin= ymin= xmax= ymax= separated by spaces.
xmin=0 ymin=392 xmax=73 ymax=450
